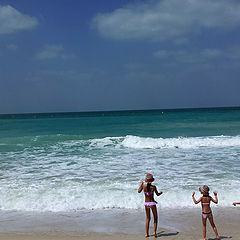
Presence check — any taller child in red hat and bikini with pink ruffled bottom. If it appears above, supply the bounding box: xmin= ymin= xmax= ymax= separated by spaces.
xmin=138 ymin=173 xmax=163 ymax=237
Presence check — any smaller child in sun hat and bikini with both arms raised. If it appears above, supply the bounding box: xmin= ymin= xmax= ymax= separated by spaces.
xmin=192 ymin=185 xmax=220 ymax=240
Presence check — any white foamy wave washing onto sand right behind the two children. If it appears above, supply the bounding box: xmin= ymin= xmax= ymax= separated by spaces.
xmin=0 ymin=188 xmax=237 ymax=212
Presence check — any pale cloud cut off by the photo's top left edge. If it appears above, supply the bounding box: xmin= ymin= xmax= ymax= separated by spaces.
xmin=0 ymin=5 xmax=38 ymax=34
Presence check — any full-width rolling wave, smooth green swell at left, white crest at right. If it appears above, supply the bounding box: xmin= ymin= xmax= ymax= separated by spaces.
xmin=0 ymin=134 xmax=240 ymax=149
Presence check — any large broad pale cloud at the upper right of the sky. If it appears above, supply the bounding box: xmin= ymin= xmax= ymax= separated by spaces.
xmin=93 ymin=0 xmax=240 ymax=42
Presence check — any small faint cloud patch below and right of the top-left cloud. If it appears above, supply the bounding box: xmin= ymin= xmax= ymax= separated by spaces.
xmin=35 ymin=44 xmax=74 ymax=60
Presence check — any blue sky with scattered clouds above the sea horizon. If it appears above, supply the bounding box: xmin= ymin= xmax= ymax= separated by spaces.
xmin=0 ymin=0 xmax=240 ymax=113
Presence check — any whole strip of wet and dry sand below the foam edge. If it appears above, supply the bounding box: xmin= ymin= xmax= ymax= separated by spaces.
xmin=0 ymin=207 xmax=240 ymax=240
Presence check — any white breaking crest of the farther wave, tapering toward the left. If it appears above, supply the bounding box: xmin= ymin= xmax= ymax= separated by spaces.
xmin=56 ymin=135 xmax=240 ymax=149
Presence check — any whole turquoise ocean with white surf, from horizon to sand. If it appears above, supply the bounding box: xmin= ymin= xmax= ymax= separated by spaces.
xmin=0 ymin=108 xmax=240 ymax=232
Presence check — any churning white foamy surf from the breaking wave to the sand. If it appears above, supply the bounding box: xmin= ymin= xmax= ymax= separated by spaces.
xmin=0 ymin=136 xmax=240 ymax=212
